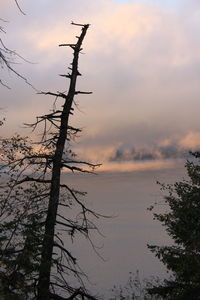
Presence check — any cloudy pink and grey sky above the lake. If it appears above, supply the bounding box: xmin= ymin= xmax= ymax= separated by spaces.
xmin=0 ymin=0 xmax=200 ymax=169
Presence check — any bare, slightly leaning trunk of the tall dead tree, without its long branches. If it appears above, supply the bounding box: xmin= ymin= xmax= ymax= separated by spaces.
xmin=37 ymin=23 xmax=89 ymax=300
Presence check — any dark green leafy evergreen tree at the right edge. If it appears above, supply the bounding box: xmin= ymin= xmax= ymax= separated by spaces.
xmin=148 ymin=152 xmax=200 ymax=300
